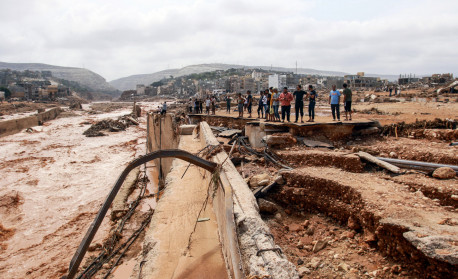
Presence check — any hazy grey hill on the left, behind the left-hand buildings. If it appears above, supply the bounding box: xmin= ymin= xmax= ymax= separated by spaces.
xmin=0 ymin=62 xmax=120 ymax=95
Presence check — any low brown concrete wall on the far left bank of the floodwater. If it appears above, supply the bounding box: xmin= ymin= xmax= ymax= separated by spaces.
xmin=0 ymin=107 xmax=62 ymax=137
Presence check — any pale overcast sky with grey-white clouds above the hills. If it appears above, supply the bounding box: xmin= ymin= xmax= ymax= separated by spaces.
xmin=0 ymin=0 xmax=458 ymax=81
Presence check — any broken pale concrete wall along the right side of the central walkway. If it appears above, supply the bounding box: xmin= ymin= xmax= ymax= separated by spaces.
xmin=199 ymin=122 xmax=299 ymax=279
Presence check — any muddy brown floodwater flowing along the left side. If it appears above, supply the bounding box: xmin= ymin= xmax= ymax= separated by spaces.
xmin=0 ymin=106 xmax=155 ymax=278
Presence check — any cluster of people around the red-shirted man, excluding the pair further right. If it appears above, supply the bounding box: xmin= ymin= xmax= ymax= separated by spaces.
xmin=257 ymin=84 xmax=317 ymax=123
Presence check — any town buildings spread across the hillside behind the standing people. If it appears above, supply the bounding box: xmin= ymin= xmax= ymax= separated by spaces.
xmin=120 ymin=68 xmax=456 ymax=100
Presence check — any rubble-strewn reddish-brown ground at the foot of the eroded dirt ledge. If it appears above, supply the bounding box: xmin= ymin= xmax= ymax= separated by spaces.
xmin=264 ymin=210 xmax=412 ymax=279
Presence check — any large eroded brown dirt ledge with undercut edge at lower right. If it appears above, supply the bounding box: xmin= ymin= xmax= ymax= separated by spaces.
xmin=272 ymin=168 xmax=458 ymax=278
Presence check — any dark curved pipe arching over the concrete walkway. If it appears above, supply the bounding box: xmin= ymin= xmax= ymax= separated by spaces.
xmin=62 ymin=149 xmax=218 ymax=279
